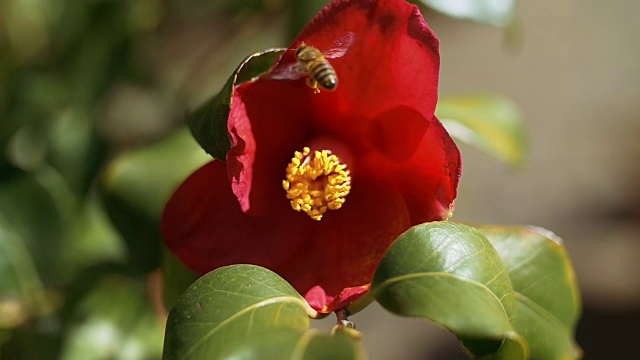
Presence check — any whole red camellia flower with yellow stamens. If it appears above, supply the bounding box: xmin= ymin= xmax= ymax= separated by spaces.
xmin=162 ymin=0 xmax=461 ymax=313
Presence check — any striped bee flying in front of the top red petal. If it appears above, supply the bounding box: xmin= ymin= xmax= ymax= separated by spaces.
xmin=271 ymin=32 xmax=355 ymax=93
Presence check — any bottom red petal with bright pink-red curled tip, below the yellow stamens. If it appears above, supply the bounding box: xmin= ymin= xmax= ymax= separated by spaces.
xmin=278 ymin=179 xmax=410 ymax=312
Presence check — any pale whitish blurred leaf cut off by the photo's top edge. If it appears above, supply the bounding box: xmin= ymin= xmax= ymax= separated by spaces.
xmin=419 ymin=0 xmax=516 ymax=27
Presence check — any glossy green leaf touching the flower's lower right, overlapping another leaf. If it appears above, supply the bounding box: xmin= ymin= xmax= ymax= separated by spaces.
xmin=371 ymin=222 xmax=527 ymax=359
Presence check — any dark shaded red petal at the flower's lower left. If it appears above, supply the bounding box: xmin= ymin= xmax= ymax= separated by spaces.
xmin=161 ymin=161 xmax=304 ymax=274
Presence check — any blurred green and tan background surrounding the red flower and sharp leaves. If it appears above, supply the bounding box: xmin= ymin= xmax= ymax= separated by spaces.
xmin=0 ymin=0 xmax=640 ymax=360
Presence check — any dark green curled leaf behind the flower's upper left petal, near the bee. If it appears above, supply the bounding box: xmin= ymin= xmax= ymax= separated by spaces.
xmin=186 ymin=49 xmax=286 ymax=161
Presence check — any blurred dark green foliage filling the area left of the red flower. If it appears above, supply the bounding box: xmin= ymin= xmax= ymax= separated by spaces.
xmin=0 ymin=0 xmax=520 ymax=360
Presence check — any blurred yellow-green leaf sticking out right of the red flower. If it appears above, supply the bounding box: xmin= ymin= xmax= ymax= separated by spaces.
xmin=436 ymin=95 xmax=526 ymax=166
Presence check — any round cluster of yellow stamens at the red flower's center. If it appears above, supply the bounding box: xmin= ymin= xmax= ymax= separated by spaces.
xmin=282 ymin=147 xmax=351 ymax=221
